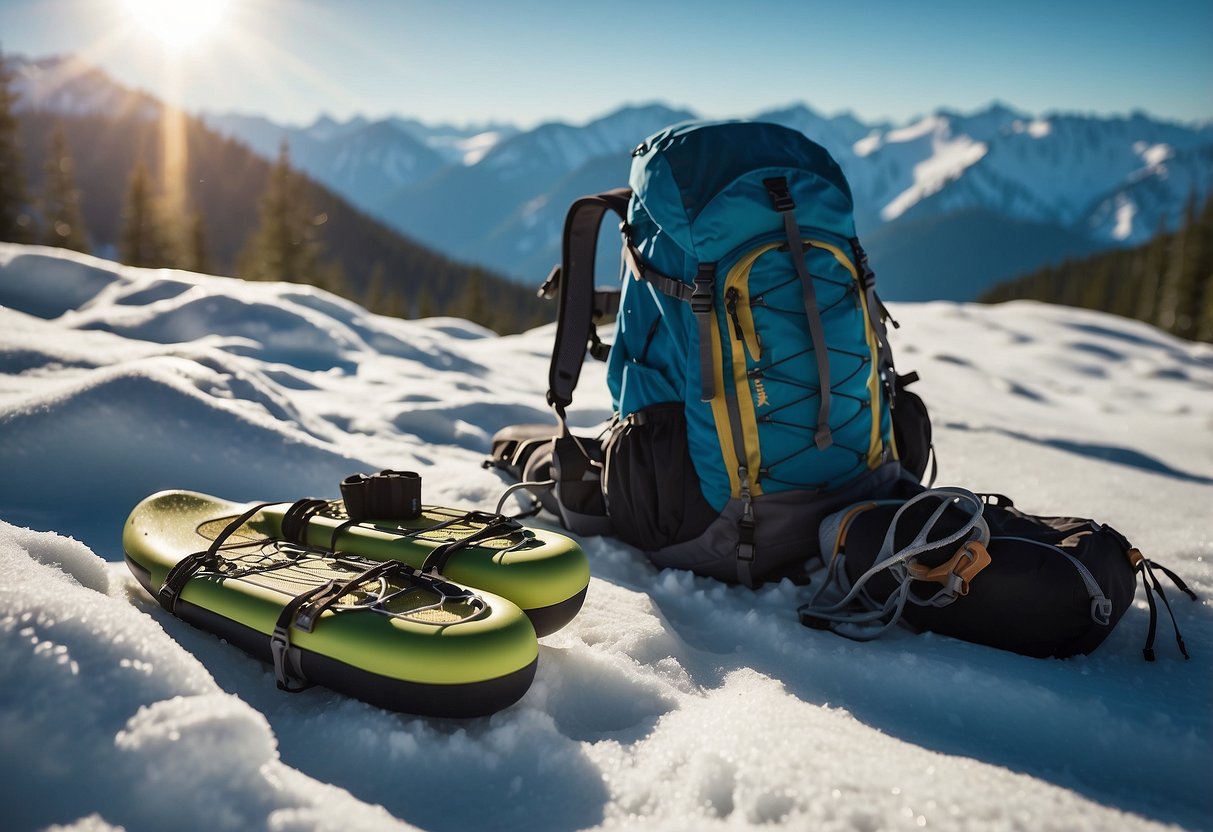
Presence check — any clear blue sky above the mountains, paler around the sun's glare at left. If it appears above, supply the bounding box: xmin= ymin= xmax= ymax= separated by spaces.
xmin=0 ymin=0 xmax=1213 ymax=126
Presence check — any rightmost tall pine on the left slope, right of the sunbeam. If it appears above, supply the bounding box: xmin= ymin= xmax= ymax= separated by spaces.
xmin=237 ymin=142 xmax=321 ymax=283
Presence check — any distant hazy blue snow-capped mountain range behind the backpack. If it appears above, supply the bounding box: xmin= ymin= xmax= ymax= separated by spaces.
xmin=11 ymin=53 xmax=1213 ymax=300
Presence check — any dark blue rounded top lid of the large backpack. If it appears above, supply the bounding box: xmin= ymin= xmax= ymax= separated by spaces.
xmin=628 ymin=121 xmax=855 ymax=265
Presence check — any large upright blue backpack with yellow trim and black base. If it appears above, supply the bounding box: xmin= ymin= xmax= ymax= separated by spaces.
xmin=490 ymin=121 xmax=930 ymax=586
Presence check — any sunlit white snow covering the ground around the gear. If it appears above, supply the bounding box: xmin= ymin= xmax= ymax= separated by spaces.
xmin=0 ymin=245 xmax=1213 ymax=831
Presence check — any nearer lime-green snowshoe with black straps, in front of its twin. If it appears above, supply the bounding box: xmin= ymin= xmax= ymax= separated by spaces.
xmin=123 ymin=491 xmax=539 ymax=717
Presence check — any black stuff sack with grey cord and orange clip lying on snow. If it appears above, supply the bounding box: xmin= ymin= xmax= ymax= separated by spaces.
xmin=799 ymin=488 xmax=1196 ymax=661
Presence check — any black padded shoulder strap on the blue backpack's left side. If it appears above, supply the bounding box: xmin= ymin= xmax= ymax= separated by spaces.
xmin=540 ymin=188 xmax=632 ymax=418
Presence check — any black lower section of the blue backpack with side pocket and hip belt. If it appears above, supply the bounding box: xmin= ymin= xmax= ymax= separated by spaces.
xmin=484 ymin=414 xmax=921 ymax=588
